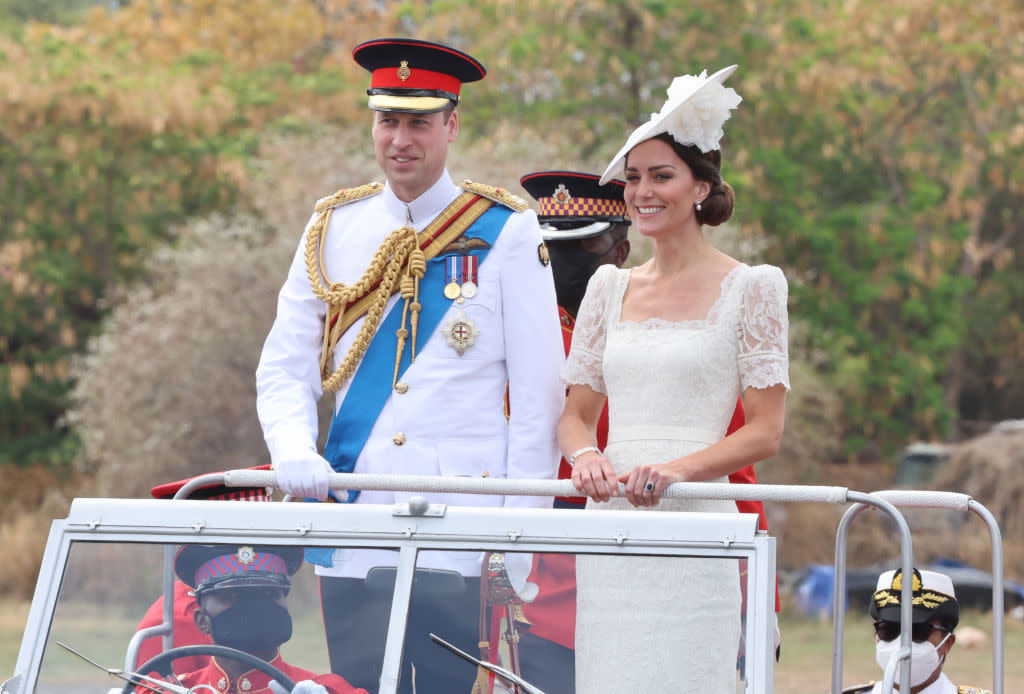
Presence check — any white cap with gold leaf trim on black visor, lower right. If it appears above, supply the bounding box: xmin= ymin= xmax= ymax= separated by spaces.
xmin=867 ymin=569 xmax=959 ymax=628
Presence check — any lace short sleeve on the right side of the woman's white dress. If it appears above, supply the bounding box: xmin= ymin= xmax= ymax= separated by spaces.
xmin=738 ymin=265 xmax=790 ymax=390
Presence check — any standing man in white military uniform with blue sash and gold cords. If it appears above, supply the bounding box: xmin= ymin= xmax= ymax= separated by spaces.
xmin=256 ymin=39 xmax=563 ymax=694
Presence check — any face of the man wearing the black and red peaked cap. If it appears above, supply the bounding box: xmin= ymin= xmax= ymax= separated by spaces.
xmin=373 ymin=111 xmax=459 ymax=203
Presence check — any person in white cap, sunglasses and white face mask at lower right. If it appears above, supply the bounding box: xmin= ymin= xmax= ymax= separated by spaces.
xmin=845 ymin=569 xmax=990 ymax=694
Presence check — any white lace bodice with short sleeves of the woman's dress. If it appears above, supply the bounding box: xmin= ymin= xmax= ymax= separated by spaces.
xmin=562 ymin=264 xmax=790 ymax=445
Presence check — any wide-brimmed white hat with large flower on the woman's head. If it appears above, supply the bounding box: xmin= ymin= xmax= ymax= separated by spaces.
xmin=600 ymin=66 xmax=743 ymax=185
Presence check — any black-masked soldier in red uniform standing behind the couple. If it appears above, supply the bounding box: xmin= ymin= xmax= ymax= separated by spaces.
xmin=519 ymin=171 xmax=778 ymax=694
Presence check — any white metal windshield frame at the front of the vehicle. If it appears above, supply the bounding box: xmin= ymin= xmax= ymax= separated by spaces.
xmin=9 ymin=498 xmax=775 ymax=694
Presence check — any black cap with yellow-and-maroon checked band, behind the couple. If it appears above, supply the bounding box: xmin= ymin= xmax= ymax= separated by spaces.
xmin=519 ymin=171 xmax=630 ymax=241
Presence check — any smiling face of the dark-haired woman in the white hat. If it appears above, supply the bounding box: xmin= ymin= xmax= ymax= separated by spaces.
xmin=625 ymin=139 xmax=711 ymax=236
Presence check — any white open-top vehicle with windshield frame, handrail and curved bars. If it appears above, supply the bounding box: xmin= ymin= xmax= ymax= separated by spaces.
xmin=0 ymin=471 xmax=1002 ymax=694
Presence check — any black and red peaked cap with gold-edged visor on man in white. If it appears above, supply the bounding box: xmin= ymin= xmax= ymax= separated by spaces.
xmin=352 ymin=39 xmax=487 ymax=114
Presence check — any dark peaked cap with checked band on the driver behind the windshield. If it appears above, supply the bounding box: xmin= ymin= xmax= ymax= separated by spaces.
xmin=174 ymin=545 xmax=302 ymax=597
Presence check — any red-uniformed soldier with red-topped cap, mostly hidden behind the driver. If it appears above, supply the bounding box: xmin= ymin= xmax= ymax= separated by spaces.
xmin=135 ymin=465 xmax=270 ymax=673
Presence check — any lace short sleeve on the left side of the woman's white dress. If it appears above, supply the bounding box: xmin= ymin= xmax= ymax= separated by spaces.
xmin=562 ymin=265 xmax=615 ymax=394
